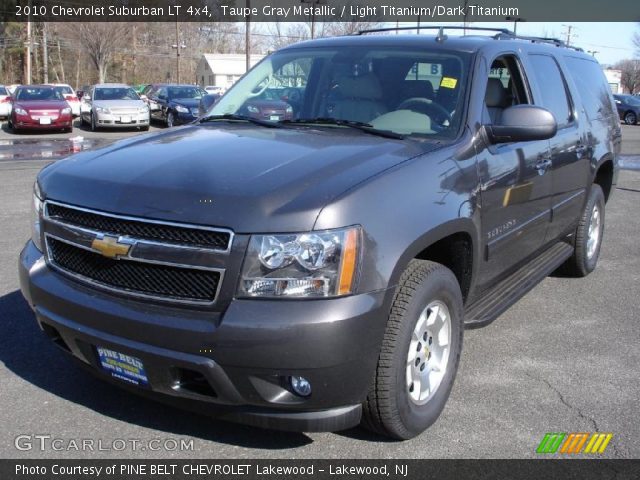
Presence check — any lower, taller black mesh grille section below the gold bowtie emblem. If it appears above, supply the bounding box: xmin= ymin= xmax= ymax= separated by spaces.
xmin=47 ymin=237 xmax=220 ymax=302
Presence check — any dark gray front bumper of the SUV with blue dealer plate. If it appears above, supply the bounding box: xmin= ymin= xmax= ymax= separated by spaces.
xmin=20 ymin=242 xmax=388 ymax=431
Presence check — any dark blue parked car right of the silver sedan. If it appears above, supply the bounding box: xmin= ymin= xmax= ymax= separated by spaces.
xmin=150 ymin=84 xmax=207 ymax=127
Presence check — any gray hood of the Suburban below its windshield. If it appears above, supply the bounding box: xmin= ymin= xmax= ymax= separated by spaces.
xmin=39 ymin=124 xmax=436 ymax=233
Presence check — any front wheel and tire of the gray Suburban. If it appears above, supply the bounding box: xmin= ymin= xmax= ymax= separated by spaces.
xmin=362 ymin=260 xmax=464 ymax=440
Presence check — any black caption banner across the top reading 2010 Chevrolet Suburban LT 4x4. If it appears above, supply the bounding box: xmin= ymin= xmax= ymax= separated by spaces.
xmin=0 ymin=0 xmax=640 ymax=22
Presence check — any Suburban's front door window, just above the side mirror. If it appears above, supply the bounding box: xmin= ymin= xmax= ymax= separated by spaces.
xmin=483 ymin=55 xmax=531 ymax=125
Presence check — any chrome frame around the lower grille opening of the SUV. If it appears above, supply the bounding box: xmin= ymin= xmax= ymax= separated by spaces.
xmin=44 ymin=232 xmax=225 ymax=306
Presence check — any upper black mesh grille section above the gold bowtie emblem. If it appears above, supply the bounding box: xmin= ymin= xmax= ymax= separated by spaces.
xmin=47 ymin=203 xmax=231 ymax=251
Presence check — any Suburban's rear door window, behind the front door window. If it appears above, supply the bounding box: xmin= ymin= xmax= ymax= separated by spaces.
xmin=529 ymin=54 xmax=572 ymax=128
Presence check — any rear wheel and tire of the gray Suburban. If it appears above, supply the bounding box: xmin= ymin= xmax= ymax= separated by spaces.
xmin=563 ymin=183 xmax=605 ymax=277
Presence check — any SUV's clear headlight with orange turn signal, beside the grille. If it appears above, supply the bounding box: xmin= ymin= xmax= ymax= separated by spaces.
xmin=238 ymin=227 xmax=361 ymax=297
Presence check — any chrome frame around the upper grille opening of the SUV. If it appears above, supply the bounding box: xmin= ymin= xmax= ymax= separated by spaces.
xmin=43 ymin=200 xmax=235 ymax=254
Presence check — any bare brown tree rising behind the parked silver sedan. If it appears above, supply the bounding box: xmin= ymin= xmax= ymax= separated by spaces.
xmin=68 ymin=22 xmax=130 ymax=83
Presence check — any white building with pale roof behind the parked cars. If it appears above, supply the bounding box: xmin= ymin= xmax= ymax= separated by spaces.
xmin=196 ymin=53 xmax=264 ymax=89
